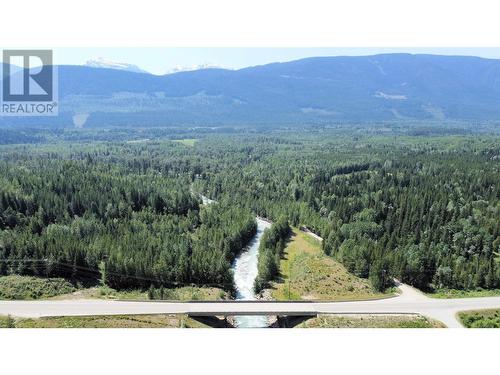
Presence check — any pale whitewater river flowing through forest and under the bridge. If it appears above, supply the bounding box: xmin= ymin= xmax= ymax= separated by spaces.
xmin=201 ymin=195 xmax=271 ymax=328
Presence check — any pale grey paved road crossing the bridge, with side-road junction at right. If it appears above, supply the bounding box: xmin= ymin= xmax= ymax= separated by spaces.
xmin=0 ymin=285 xmax=500 ymax=328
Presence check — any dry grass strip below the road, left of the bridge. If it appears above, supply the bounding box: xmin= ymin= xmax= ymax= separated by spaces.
xmin=0 ymin=315 xmax=207 ymax=328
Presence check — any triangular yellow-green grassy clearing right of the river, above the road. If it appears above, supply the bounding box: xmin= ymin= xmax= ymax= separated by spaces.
xmin=271 ymin=228 xmax=392 ymax=300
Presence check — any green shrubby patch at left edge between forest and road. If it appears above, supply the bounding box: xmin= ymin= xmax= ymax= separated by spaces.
xmin=0 ymin=275 xmax=76 ymax=300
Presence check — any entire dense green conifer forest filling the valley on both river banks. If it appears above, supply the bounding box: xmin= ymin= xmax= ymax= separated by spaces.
xmin=0 ymin=130 xmax=500 ymax=290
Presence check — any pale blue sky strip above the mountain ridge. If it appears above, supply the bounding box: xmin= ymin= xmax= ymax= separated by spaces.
xmin=45 ymin=47 xmax=500 ymax=74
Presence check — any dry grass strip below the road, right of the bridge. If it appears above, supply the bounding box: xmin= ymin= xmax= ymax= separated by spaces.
xmin=297 ymin=315 xmax=445 ymax=328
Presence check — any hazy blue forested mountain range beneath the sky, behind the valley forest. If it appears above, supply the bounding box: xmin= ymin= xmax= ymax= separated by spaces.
xmin=0 ymin=54 xmax=500 ymax=126
